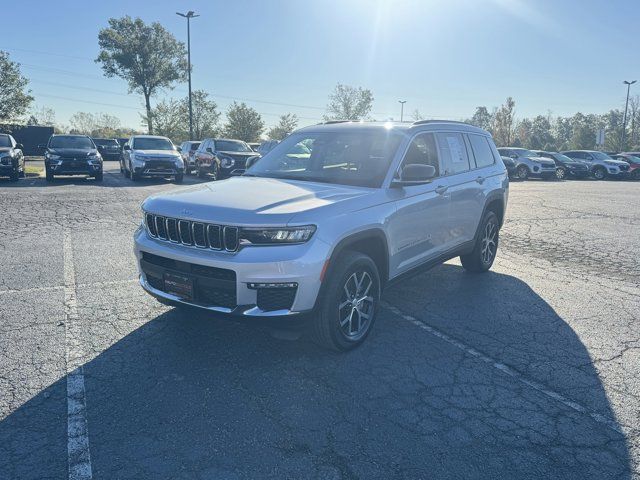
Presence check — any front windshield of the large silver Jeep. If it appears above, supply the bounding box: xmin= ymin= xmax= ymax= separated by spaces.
xmin=247 ymin=130 xmax=402 ymax=187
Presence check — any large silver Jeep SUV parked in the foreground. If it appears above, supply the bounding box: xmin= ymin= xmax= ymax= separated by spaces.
xmin=134 ymin=121 xmax=509 ymax=350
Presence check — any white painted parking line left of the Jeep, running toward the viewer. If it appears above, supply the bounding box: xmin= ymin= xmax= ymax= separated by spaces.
xmin=63 ymin=225 xmax=92 ymax=480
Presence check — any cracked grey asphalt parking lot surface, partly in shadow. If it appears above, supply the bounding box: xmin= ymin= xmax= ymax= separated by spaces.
xmin=0 ymin=162 xmax=640 ymax=480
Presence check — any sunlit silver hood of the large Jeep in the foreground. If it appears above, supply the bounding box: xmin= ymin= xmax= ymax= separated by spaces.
xmin=142 ymin=177 xmax=377 ymax=225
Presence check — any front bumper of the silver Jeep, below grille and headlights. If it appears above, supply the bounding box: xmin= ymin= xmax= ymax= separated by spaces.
xmin=134 ymin=227 xmax=330 ymax=317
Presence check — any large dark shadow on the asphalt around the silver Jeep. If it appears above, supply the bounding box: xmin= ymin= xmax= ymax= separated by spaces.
xmin=0 ymin=264 xmax=631 ymax=479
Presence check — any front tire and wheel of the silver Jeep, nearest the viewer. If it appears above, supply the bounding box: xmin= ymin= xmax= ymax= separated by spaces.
xmin=310 ymin=252 xmax=380 ymax=352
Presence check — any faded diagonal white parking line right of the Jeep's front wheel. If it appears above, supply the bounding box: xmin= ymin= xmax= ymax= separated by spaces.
xmin=382 ymin=302 xmax=624 ymax=434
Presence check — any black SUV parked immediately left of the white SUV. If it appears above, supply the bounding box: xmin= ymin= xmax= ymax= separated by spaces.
xmin=40 ymin=135 xmax=102 ymax=182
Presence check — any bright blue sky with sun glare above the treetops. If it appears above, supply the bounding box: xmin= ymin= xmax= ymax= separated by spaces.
xmin=0 ymin=0 xmax=640 ymax=128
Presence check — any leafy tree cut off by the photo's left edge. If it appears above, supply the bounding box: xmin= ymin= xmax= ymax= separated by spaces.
xmin=0 ymin=50 xmax=33 ymax=120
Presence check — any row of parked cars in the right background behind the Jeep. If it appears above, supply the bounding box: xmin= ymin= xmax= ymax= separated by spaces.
xmin=498 ymin=147 xmax=640 ymax=180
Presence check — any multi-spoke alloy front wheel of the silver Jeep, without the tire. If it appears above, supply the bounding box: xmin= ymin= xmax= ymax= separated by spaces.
xmin=338 ymin=270 xmax=375 ymax=340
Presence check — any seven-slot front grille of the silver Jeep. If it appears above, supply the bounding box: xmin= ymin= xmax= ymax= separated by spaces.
xmin=144 ymin=213 xmax=240 ymax=252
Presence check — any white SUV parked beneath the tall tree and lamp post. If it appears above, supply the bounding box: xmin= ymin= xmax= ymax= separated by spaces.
xmin=120 ymin=135 xmax=184 ymax=183
